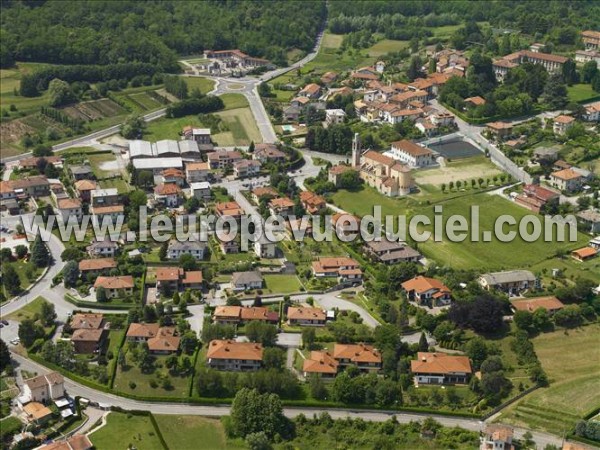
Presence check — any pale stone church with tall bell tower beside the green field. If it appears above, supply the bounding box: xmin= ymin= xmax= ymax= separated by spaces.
xmin=352 ymin=134 xmax=415 ymax=197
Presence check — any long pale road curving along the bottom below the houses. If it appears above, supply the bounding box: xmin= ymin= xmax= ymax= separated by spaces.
xmin=12 ymin=354 xmax=561 ymax=448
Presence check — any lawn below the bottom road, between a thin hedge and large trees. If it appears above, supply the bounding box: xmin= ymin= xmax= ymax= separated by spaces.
xmin=155 ymin=415 xmax=246 ymax=450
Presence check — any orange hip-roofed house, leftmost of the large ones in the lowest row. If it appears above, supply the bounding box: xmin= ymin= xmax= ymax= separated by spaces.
xmin=206 ymin=339 xmax=263 ymax=371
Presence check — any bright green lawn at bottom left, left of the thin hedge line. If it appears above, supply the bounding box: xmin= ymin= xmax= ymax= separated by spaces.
xmin=89 ymin=412 xmax=164 ymax=450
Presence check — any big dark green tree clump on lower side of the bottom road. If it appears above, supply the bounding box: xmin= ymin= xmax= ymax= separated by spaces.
xmin=231 ymin=388 xmax=290 ymax=439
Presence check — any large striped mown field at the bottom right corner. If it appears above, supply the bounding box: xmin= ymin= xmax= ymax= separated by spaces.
xmin=501 ymin=323 xmax=600 ymax=435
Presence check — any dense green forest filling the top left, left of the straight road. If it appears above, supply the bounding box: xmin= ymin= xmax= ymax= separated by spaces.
xmin=0 ymin=0 xmax=326 ymax=71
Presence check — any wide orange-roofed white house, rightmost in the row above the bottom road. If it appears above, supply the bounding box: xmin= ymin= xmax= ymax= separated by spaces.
xmin=410 ymin=352 xmax=473 ymax=385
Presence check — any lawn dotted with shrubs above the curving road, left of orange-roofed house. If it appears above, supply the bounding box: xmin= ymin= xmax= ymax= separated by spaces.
xmin=114 ymin=346 xmax=191 ymax=398
